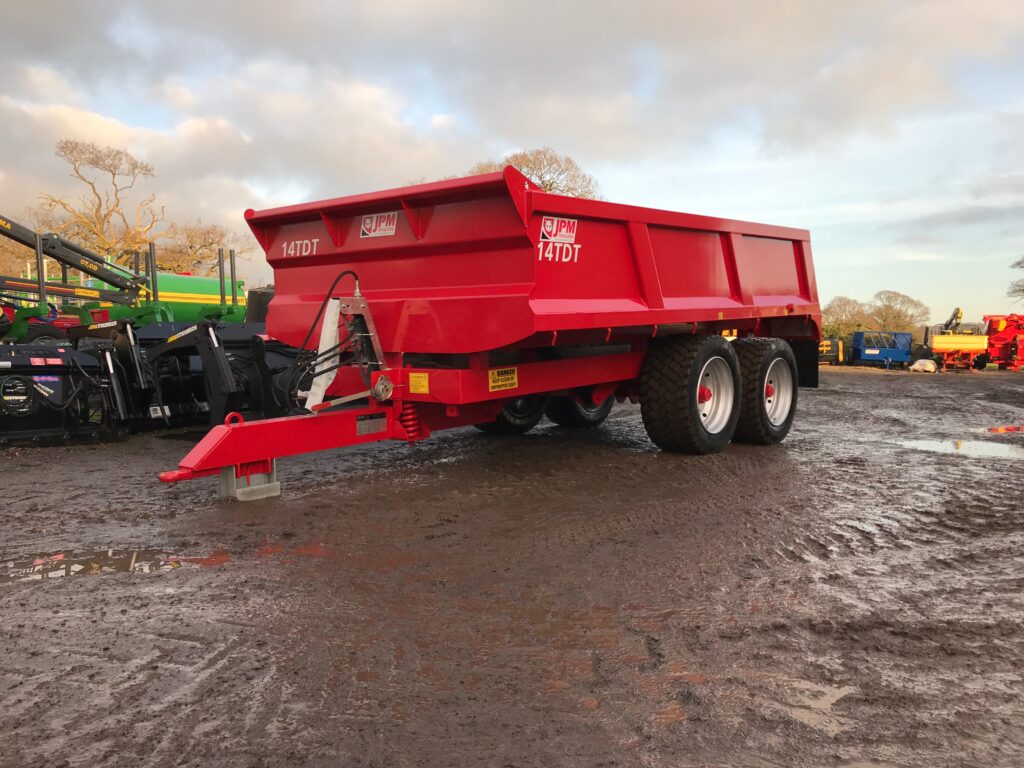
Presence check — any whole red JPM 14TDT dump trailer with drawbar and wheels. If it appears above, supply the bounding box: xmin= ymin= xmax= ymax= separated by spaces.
xmin=161 ymin=167 xmax=821 ymax=499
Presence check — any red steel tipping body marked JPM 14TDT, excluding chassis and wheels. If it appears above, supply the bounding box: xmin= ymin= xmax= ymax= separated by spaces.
xmin=253 ymin=169 xmax=819 ymax=362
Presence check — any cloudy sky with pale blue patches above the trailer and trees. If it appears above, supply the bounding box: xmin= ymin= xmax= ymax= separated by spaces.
xmin=0 ymin=0 xmax=1024 ymax=322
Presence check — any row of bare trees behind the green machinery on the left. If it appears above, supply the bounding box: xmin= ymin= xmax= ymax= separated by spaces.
xmin=0 ymin=139 xmax=252 ymax=274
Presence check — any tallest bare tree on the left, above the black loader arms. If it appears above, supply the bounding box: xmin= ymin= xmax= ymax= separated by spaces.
xmin=40 ymin=138 xmax=164 ymax=263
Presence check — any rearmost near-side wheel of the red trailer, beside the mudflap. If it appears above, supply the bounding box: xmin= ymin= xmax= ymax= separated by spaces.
xmin=733 ymin=339 xmax=799 ymax=445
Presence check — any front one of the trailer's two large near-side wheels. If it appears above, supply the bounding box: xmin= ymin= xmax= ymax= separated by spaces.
xmin=640 ymin=336 xmax=739 ymax=454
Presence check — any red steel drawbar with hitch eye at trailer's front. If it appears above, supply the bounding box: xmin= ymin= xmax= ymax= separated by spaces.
xmin=160 ymin=403 xmax=395 ymax=482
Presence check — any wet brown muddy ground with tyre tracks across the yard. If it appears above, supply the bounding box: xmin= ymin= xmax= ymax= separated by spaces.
xmin=0 ymin=370 xmax=1024 ymax=767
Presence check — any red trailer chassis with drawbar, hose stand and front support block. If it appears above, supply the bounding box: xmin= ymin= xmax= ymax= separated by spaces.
xmin=160 ymin=288 xmax=645 ymax=501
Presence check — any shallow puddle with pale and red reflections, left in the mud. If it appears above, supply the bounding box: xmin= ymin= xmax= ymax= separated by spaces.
xmin=0 ymin=543 xmax=333 ymax=584
